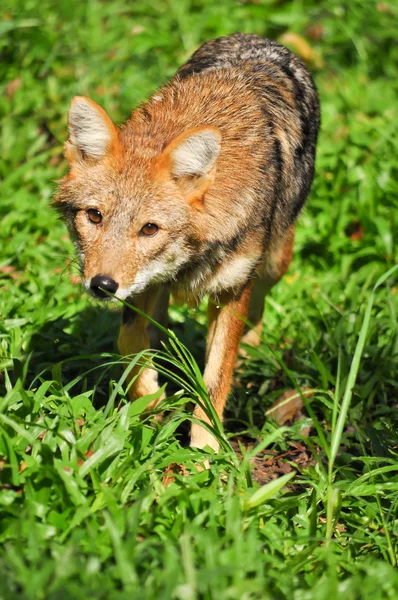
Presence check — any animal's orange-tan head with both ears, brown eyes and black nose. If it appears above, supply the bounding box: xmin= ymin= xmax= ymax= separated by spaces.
xmin=54 ymin=97 xmax=220 ymax=299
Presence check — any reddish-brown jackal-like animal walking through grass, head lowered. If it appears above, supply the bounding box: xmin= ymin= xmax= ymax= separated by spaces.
xmin=54 ymin=33 xmax=319 ymax=449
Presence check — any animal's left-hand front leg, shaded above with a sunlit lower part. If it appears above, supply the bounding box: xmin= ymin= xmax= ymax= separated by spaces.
xmin=118 ymin=288 xmax=166 ymax=408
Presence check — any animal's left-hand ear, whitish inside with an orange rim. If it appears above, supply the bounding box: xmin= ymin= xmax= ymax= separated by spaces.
xmin=65 ymin=96 xmax=118 ymax=163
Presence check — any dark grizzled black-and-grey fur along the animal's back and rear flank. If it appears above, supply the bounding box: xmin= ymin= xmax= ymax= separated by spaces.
xmin=176 ymin=33 xmax=320 ymax=239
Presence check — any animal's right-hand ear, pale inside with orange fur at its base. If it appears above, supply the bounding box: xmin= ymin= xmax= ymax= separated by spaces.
xmin=157 ymin=126 xmax=221 ymax=200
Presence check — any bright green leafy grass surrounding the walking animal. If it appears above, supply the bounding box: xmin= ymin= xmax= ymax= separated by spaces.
xmin=0 ymin=0 xmax=398 ymax=600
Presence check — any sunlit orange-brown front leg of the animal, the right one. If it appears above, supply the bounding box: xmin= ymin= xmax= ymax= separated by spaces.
xmin=191 ymin=281 xmax=251 ymax=450
